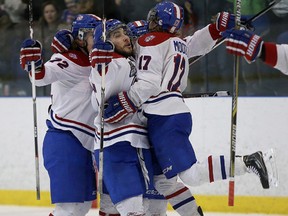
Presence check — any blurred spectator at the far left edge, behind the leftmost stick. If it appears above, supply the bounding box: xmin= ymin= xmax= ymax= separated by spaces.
xmin=0 ymin=0 xmax=31 ymax=96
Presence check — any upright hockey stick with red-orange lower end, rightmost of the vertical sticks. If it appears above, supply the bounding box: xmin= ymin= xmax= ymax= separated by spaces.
xmin=228 ymin=0 xmax=241 ymax=206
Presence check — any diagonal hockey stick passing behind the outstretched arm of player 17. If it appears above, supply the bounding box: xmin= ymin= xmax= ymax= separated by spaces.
xmin=189 ymin=0 xmax=281 ymax=66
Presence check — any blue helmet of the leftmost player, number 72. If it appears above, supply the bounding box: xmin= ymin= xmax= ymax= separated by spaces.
xmin=72 ymin=14 xmax=102 ymax=40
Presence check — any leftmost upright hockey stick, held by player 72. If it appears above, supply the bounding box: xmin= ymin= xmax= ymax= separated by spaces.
xmin=28 ymin=0 xmax=40 ymax=200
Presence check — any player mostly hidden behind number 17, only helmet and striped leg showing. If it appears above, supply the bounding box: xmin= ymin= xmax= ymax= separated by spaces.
xmin=127 ymin=20 xmax=203 ymax=216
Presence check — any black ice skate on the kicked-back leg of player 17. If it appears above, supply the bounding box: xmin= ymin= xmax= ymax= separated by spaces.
xmin=243 ymin=151 xmax=269 ymax=189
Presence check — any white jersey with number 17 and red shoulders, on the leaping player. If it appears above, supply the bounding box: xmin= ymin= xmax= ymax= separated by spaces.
xmin=128 ymin=25 xmax=220 ymax=115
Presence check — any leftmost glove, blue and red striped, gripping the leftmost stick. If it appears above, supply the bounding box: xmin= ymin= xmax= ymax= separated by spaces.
xmin=20 ymin=39 xmax=43 ymax=72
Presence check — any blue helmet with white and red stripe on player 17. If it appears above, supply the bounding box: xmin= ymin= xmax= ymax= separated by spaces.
xmin=147 ymin=1 xmax=184 ymax=33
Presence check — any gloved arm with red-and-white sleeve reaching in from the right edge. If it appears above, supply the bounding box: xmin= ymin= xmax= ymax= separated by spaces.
xmin=222 ymin=30 xmax=288 ymax=75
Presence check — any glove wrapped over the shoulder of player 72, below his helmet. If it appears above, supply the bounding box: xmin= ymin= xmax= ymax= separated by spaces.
xmin=51 ymin=29 xmax=74 ymax=53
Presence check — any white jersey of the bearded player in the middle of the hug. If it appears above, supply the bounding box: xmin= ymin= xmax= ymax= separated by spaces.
xmin=90 ymin=54 xmax=149 ymax=149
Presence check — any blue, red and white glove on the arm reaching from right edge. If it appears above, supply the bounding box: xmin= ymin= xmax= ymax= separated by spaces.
xmin=222 ymin=29 xmax=263 ymax=63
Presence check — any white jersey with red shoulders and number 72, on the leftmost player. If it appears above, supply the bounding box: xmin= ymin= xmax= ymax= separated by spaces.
xmin=35 ymin=51 xmax=96 ymax=151
